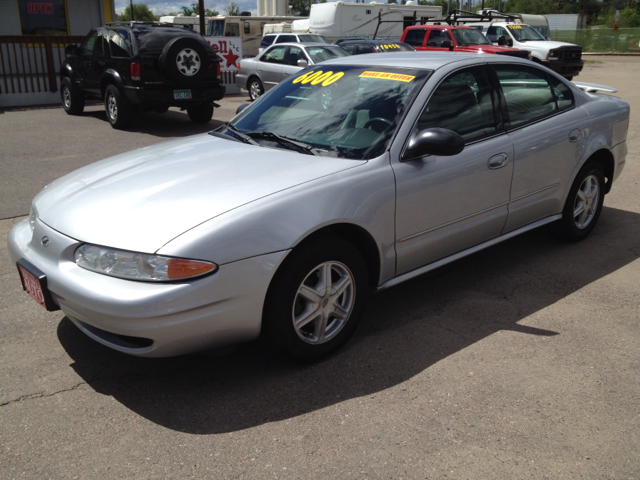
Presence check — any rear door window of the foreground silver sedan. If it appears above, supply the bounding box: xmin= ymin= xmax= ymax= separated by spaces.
xmin=493 ymin=65 xmax=564 ymax=127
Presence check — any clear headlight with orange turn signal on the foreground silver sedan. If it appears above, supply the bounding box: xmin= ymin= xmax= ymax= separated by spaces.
xmin=74 ymin=243 xmax=218 ymax=282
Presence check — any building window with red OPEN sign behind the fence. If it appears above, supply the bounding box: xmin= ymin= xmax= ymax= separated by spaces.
xmin=17 ymin=0 xmax=69 ymax=35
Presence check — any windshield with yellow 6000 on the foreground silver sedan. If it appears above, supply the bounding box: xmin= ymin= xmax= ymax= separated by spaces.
xmin=226 ymin=65 xmax=431 ymax=159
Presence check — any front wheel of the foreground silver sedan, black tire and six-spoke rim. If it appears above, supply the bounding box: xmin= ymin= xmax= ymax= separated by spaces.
xmin=261 ymin=238 xmax=370 ymax=362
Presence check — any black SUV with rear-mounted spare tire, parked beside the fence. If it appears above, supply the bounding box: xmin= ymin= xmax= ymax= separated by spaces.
xmin=60 ymin=22 xmax=225 ymax=128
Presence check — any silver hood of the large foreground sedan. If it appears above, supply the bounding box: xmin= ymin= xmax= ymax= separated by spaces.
xmin=33 ymin=134 xmax=366 ymax=253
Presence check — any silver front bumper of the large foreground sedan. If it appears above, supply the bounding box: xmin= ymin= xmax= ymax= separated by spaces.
xmin=8 ymin=219 xmax=287 ymax=357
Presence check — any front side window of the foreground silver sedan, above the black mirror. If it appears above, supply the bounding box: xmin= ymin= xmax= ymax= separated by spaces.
xmin=418 ymin=67 xmax=496 ymax=143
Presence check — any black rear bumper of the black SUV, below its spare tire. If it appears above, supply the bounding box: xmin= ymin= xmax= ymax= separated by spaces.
xmin=124 ymin=85 xmax=226 ymax=107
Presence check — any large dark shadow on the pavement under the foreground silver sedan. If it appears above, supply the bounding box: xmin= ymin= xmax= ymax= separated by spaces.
xmin=58 ymin=208 xmax=640 ymax=434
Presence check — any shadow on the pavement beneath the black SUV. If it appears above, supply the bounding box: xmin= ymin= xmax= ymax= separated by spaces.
xmin=82 ymin=107 xmax=225 ymax=137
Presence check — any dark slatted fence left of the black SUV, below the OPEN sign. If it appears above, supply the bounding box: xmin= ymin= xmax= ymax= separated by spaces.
xmin=0 ymin=35 xmax=84 ymax=94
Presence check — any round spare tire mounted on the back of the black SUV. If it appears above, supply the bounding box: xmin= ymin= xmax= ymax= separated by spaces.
xmin=160 ymin=37 xmax=211 ymax=85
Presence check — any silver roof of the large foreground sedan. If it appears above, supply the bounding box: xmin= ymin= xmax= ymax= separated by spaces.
xmin=322 ymin=51 xmax=531 ymax=70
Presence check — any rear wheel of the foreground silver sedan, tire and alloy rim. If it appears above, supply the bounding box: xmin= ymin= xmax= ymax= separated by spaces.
xmin=554 ymin=161 xmax=604 ymax=242
